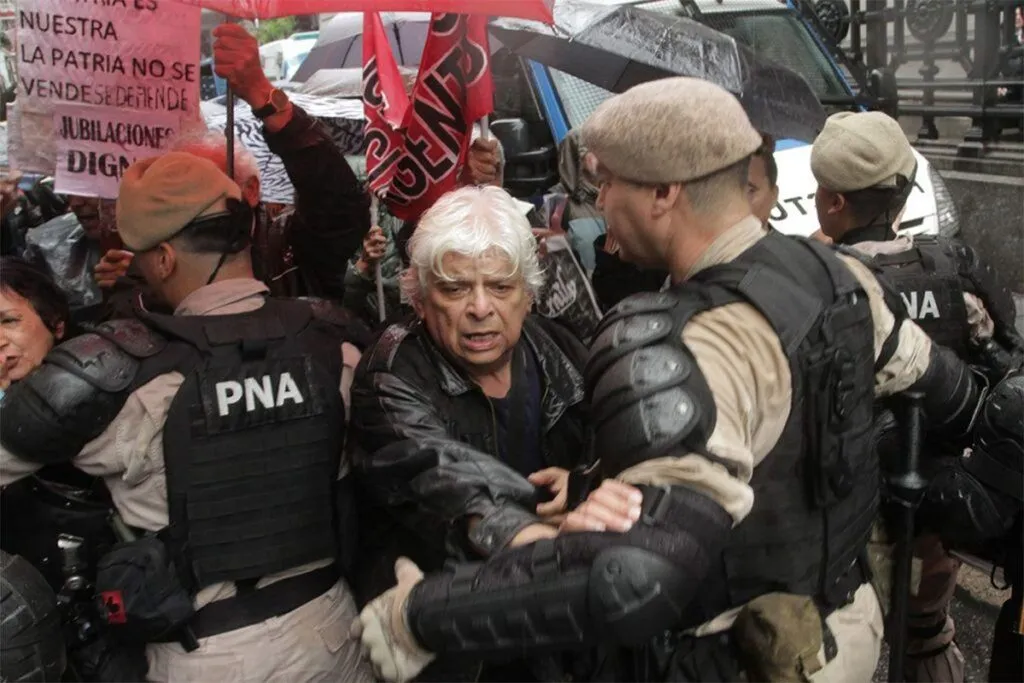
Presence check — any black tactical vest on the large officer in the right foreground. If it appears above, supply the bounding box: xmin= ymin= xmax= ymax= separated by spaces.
xmin=684 ymin=232 xmax=881 ymax=618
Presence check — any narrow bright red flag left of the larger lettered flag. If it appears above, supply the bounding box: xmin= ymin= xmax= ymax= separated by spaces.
xmin=362 ymin=12 xmax=409 ymax=195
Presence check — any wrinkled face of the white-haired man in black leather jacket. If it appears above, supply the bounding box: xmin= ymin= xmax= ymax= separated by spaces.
xmin=416 ymin=253 xmax=532 ymax=374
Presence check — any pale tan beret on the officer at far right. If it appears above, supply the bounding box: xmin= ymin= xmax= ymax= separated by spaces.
xmin=811 ymin=112 xmax=918 ymax=193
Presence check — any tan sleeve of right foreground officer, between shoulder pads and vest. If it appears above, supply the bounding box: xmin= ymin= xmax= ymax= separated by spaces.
xmin=618 ymin=303 xmax=793 ymax=523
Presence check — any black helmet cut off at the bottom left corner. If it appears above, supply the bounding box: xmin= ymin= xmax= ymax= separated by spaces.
xmin=0 ymin=551 xmax=67 ymax=681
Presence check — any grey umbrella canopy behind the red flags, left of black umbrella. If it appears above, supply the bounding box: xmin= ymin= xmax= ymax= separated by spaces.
xmin=292 ymin=12 xmax=430 ymax=82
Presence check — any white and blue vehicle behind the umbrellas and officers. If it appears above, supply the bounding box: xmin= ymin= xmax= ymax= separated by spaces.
xmin=495 ymin=0 xmax=959 ymax=240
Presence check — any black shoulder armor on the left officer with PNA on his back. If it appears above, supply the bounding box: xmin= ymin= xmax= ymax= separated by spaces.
xmin=0 ymin=326 xmax=144 ymax=465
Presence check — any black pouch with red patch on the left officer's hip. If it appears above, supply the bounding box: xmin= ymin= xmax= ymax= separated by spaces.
xmin=96 ymin=535 xmax=196 ymax=643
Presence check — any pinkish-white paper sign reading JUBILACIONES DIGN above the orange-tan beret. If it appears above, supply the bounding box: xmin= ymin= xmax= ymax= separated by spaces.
xmin=53 ymin=103 xmax=181 ymax=199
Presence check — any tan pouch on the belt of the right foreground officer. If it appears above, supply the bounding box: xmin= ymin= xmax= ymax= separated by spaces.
xmin=732 ymin=593 xmax=822 ymax=681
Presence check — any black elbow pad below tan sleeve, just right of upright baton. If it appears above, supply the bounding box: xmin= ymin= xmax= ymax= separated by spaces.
xmin=907 ymin=344 xmax=988 ymax=437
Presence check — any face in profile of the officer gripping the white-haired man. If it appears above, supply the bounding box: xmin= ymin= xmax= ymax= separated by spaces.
xmin=597 ymin=165 xmax=666 ymax=268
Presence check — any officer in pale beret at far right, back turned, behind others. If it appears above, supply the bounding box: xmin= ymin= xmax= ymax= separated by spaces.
xmin=811 ymin=112 xmax=1024 ymax=682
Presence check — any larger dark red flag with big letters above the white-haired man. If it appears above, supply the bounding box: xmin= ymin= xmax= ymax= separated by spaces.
xmin=368 ymin=14 xmax=494 ymax=220
